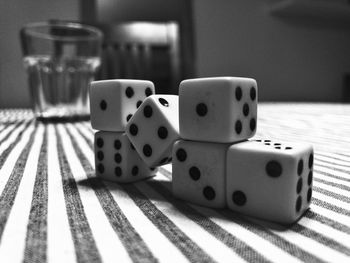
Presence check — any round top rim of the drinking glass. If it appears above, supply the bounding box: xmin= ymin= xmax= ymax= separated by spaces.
xmin=21 ymin=21 xmax=103 ymax=41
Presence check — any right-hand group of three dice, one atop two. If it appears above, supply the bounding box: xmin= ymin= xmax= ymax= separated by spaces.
xmin=172 ymin=77 xmax=313 ymax=224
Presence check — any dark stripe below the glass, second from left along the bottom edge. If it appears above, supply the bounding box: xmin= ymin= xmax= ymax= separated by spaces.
xmin=55 ymin=126 xmax=102 ymax=262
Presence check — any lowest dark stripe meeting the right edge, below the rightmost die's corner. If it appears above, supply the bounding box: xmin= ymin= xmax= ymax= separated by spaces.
xmin=291 ymin=224 xmax=350 ymax=256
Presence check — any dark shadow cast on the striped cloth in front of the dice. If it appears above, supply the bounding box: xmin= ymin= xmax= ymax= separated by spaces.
xmin=77 ymin=177 xmax=309 ymax=232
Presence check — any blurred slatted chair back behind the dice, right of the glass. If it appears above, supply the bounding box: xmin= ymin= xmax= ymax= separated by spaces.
xmin=98 ymin=22 xmax=181 ymax=94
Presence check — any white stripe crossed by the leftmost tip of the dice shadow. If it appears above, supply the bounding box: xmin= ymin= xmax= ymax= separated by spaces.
xmin=57 ymin=125 xmax=131 ymax=262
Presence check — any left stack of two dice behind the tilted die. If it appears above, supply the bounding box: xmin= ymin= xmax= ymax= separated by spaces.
xmin=90 ymin=79 xmax=156 ymax=183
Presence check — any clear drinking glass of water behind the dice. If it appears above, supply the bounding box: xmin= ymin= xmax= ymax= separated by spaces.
xmin=20 ymin=21 xmax=103 ymax=121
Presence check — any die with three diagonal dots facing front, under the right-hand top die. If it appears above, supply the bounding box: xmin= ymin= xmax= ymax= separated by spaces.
xmin=172 ymin=140 xmax=229 ymax=208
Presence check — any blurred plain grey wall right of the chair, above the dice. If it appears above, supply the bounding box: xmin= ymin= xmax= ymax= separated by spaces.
xmin=193 ymin=0 xmax=350 ymax=101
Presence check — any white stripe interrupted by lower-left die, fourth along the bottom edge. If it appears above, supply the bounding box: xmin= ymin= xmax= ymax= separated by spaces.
xmin=68 ymin=125 xmax=191 ymax=262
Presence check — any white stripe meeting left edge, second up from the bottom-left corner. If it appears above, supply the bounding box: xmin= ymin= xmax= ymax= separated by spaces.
xmin=0 ymin=122 xmax=34 ymax=193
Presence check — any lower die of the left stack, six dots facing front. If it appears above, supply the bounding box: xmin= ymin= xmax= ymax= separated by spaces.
xmin=95 ymin=131 xmax=156 ymax=183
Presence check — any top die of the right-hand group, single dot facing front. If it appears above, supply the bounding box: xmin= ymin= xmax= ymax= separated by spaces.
xmin=179 ymin=77 xmax=257 ymax=143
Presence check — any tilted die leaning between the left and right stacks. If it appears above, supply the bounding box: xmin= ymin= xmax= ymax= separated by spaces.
xmin=126 ymin=95 xmax=179 ymax=167
